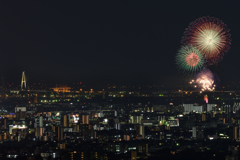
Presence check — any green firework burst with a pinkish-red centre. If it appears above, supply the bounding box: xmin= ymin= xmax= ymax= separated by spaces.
xmin=176 ymin=46 xmax=204 ymax=73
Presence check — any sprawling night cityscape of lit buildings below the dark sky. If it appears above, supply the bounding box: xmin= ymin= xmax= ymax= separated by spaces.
xmin=0 ymin=71 xmax=240 ymax=159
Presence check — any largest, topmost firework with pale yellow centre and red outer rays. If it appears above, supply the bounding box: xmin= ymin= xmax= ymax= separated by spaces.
xmin=182 ymin=16 xmax=231 ymax=65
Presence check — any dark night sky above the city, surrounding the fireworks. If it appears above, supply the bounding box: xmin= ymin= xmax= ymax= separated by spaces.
xmin=0 ymin=0 xmax=240 ymax=85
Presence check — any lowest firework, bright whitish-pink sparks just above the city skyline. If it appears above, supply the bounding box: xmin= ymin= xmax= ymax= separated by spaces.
xmin=195 ymin=69 xmax=216 ymax=91
